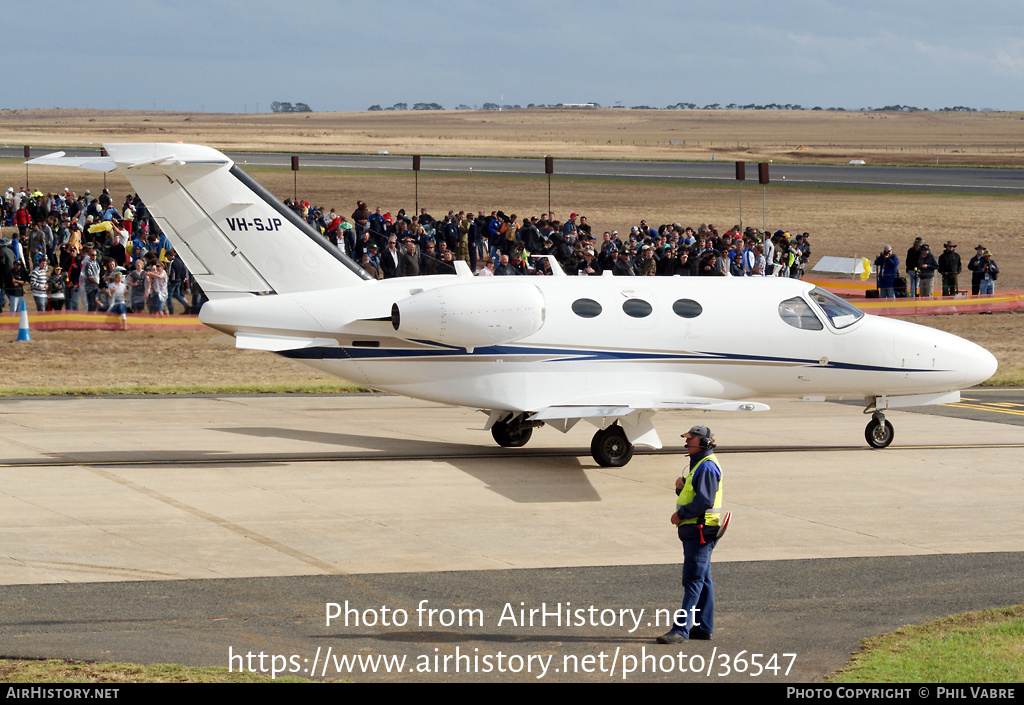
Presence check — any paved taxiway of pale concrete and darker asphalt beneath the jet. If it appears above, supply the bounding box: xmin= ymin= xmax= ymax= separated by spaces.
xmin=0 ymin=390 xmax=1024 ymax=680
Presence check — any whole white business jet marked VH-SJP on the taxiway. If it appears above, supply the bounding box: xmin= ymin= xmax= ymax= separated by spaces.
xmin=30 ymin=144 xmax=996 ymax=466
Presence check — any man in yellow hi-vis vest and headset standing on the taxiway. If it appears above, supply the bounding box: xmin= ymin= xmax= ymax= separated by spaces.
xmin=657 ymin=425 xmax=723 ymax=644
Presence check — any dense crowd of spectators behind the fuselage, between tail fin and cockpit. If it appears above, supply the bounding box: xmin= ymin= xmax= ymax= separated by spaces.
xmin=294 ymin=201 xmax=811 ymax=279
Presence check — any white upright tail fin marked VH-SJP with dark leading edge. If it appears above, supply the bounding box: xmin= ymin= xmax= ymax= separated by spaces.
xmin=104 ymin=143 xmax=372 ymax=298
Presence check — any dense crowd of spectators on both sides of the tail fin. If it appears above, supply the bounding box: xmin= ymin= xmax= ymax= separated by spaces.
xmin=0 ymin=183 xmax=810 ymax=317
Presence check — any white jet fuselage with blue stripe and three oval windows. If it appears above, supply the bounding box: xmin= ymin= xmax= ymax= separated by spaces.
xmin=201 ymin=277 xmax=995 ymax=411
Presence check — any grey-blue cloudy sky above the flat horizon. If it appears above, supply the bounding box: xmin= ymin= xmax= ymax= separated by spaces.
xmin=8 ymin=0 xmax=1024 ymax=113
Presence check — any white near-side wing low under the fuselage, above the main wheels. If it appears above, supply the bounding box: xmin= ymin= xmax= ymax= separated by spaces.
xmin=528 ymin=397 xmax=769 ymax=448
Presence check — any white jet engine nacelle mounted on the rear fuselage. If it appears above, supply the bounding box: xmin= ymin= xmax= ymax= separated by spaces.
xmin=391 ymin=279 xmax=544 ymax=353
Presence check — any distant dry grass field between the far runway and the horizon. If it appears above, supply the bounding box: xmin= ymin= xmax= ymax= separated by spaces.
xmin=6 ymin=109 xmax=1024 ymax=167
